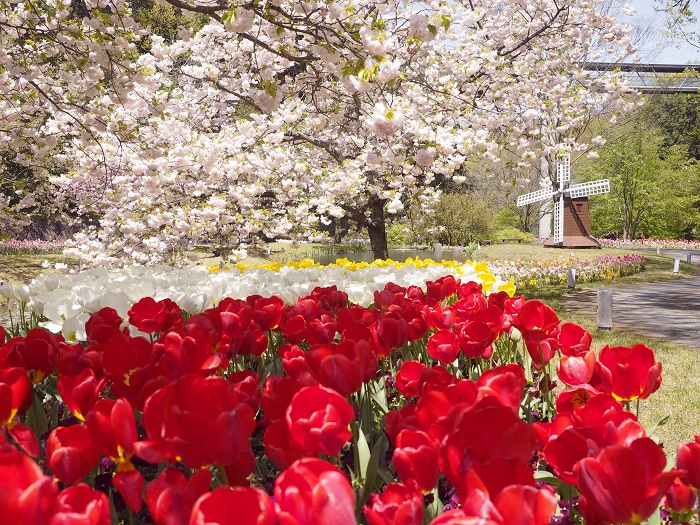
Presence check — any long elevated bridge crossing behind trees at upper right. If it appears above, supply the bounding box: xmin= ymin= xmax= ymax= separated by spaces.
xmin=583 ymin=62 xmax=700 ymax=94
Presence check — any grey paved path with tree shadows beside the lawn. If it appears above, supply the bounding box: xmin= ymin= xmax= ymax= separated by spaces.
xmin=560 ymin=250 xmax=700 ymax=350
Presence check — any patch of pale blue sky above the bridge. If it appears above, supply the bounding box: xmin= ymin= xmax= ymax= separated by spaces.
xmin=619 ymin=0 xmax=700 ymax=64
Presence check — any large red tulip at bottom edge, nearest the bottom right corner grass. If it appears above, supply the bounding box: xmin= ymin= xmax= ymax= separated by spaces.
xmin=578 ymin=438 xmax=677 ymax=525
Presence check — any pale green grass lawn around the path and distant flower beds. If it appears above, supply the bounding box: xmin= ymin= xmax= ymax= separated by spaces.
xmin=5 ymin=244 xmax=700 ymax=448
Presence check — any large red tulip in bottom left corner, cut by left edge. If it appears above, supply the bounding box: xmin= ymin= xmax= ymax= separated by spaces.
xmin=0 ymin=445 xmax=58 ymax=525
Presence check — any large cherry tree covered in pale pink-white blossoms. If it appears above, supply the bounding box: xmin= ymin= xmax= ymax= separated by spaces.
xmin=0 ymin=0 xmax=633 ymax=264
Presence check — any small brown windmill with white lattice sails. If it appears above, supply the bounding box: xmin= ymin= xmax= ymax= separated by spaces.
xmin=517 ymin=149 xmax=610 ymax=248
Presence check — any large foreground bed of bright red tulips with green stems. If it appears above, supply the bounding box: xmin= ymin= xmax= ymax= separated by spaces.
xmin=0 ymin=262 xmax=700 ymax=525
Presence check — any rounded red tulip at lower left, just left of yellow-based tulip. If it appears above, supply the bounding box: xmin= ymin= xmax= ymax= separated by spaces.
xmin=46 ymin=425 xmax=101 ymax=485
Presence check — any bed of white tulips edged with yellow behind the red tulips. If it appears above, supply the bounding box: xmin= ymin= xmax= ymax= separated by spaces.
xmin=0 ymin=259 xmax=513 ymax=341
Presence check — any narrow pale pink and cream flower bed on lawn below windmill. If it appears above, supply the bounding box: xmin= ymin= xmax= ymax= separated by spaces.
xmin=489 ymin=255 xmax=645 ymax=286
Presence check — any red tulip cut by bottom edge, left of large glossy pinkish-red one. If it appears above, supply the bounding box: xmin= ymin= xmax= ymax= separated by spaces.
xmin=189 ymin=487 xmax=276 ymax=525
